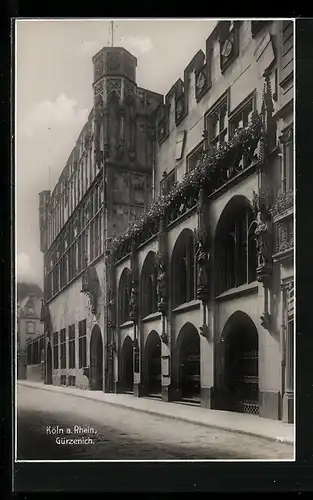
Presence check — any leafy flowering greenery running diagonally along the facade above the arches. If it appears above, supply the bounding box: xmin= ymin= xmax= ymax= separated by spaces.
xmin=111 ymin=112 xmax=262 ymax=252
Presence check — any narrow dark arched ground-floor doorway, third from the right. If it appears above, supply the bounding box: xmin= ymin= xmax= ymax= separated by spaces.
xmin=145 ymin=330 xmax=162 ymax=396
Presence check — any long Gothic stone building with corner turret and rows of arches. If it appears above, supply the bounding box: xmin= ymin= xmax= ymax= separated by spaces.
xmin=40 ymin=21 xmax=294 ymax=422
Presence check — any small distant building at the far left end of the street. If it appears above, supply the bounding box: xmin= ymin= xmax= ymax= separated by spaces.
xmin=17 ymin=293 xmax=44 ymax=380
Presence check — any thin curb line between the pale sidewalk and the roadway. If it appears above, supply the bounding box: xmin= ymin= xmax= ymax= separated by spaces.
xmin=18 ymin=381 xmax=294 ymax=446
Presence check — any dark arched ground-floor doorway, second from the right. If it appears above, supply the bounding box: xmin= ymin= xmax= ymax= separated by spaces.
xmin=177 ymin=324 xmax=201 ymax=402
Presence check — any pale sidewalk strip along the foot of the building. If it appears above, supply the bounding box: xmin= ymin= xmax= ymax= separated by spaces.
xmin=18 ymin=380 xmax=294 ymax=444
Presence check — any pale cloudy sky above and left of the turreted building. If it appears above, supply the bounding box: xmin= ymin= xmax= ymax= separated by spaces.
xmin=16 ymin=19 xmax=216 ymax=286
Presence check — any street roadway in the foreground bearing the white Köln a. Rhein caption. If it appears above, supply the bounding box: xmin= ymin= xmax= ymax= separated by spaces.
xmin=17 ymin=386 xmax=293 ymax=460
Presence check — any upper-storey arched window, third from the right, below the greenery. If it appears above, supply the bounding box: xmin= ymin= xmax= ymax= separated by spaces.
xmin=141 ymin=252 xmax=158 ymax=318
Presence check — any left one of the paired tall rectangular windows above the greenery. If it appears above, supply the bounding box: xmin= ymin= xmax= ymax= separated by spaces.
xmin=207 ymin=96 xmax=228 ymax=147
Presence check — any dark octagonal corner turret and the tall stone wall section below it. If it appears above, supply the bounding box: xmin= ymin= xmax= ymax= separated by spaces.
xmin=93 ymin=47 xmax=162 ymax=237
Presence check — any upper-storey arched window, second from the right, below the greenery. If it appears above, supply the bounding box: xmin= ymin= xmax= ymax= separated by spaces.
xmin=171 ymin=229 xmax=196 ymax=307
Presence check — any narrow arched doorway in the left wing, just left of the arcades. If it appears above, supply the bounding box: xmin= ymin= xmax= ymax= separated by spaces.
xmin=90 ymin=325 xmax=103 ymax=391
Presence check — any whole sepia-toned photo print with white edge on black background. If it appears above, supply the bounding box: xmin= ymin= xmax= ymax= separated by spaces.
xmin=14 ymin=18 xmax=296 ymax=464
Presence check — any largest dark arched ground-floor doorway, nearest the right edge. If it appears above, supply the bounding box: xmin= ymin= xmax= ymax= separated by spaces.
xmin=225 ymin=312 xmax=259 ymax=414
